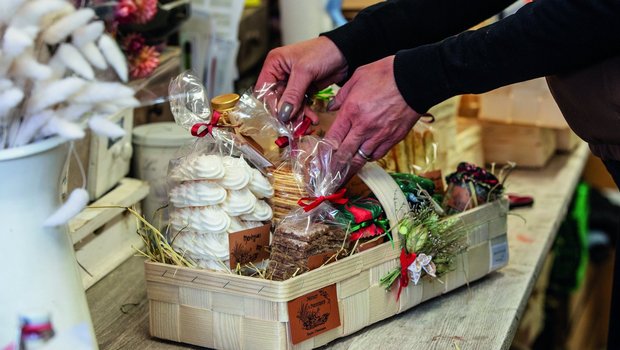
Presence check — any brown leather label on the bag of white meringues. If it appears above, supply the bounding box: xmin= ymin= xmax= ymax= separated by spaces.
xmin=228 ymin=223 xmax=271 ymax=269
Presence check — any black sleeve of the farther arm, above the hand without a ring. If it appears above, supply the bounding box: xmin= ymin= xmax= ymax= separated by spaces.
xmin=323 ymin=0 xmax=512 ymax=76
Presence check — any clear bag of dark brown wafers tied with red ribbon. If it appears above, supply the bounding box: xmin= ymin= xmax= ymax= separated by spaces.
xmin=266 ymin=136 xmax=348 ymax=280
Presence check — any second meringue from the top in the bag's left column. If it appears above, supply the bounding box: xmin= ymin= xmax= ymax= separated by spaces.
xmin=170 ymin=180 xmax=227 ymax=208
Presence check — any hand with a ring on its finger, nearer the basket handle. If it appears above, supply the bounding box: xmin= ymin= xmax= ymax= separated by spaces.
xmin=325 ymin=56 xmax=421 ymax=177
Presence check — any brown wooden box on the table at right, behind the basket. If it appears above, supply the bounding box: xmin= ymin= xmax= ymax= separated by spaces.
xmin=482 ymin=121 xmax=556 ymax=167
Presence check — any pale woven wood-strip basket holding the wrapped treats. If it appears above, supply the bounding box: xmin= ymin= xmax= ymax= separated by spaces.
xmin=145 ymin=163 xmax=508 ymax=349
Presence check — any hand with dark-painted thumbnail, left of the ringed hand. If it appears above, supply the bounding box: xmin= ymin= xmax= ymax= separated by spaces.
xmin=256 ymin=37 xmax=348 ymax=124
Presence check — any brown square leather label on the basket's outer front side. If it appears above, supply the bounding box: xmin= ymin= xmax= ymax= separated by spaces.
xmin=288 ymin=284 xmax=340 ymax=344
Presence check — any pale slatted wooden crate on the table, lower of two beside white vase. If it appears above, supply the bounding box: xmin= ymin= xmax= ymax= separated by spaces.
xmin=69 ymin=178 xmax=149 ymax=289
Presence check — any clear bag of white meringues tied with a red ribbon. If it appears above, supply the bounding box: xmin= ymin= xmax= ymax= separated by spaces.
xmin=168 ymin=72 xmax=274 ymax=271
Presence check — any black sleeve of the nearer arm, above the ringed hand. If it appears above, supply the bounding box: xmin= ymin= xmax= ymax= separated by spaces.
xmin=394 ymin=0 xmax=620 ymax=113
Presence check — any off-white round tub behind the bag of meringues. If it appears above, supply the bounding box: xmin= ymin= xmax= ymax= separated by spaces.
xmin=132 ymin=122 xmax=195 ymax=228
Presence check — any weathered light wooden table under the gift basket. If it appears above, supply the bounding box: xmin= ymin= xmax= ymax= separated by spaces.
xmin=86 ymin=144 xmax=589 ymax=350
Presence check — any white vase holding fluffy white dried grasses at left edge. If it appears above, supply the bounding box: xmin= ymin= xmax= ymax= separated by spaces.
xmin=0 ymin=137 xmax=96 ymax=349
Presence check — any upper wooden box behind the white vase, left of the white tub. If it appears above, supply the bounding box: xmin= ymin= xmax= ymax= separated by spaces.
xmin=66 ymin=108 xmax=133 ymax=201
